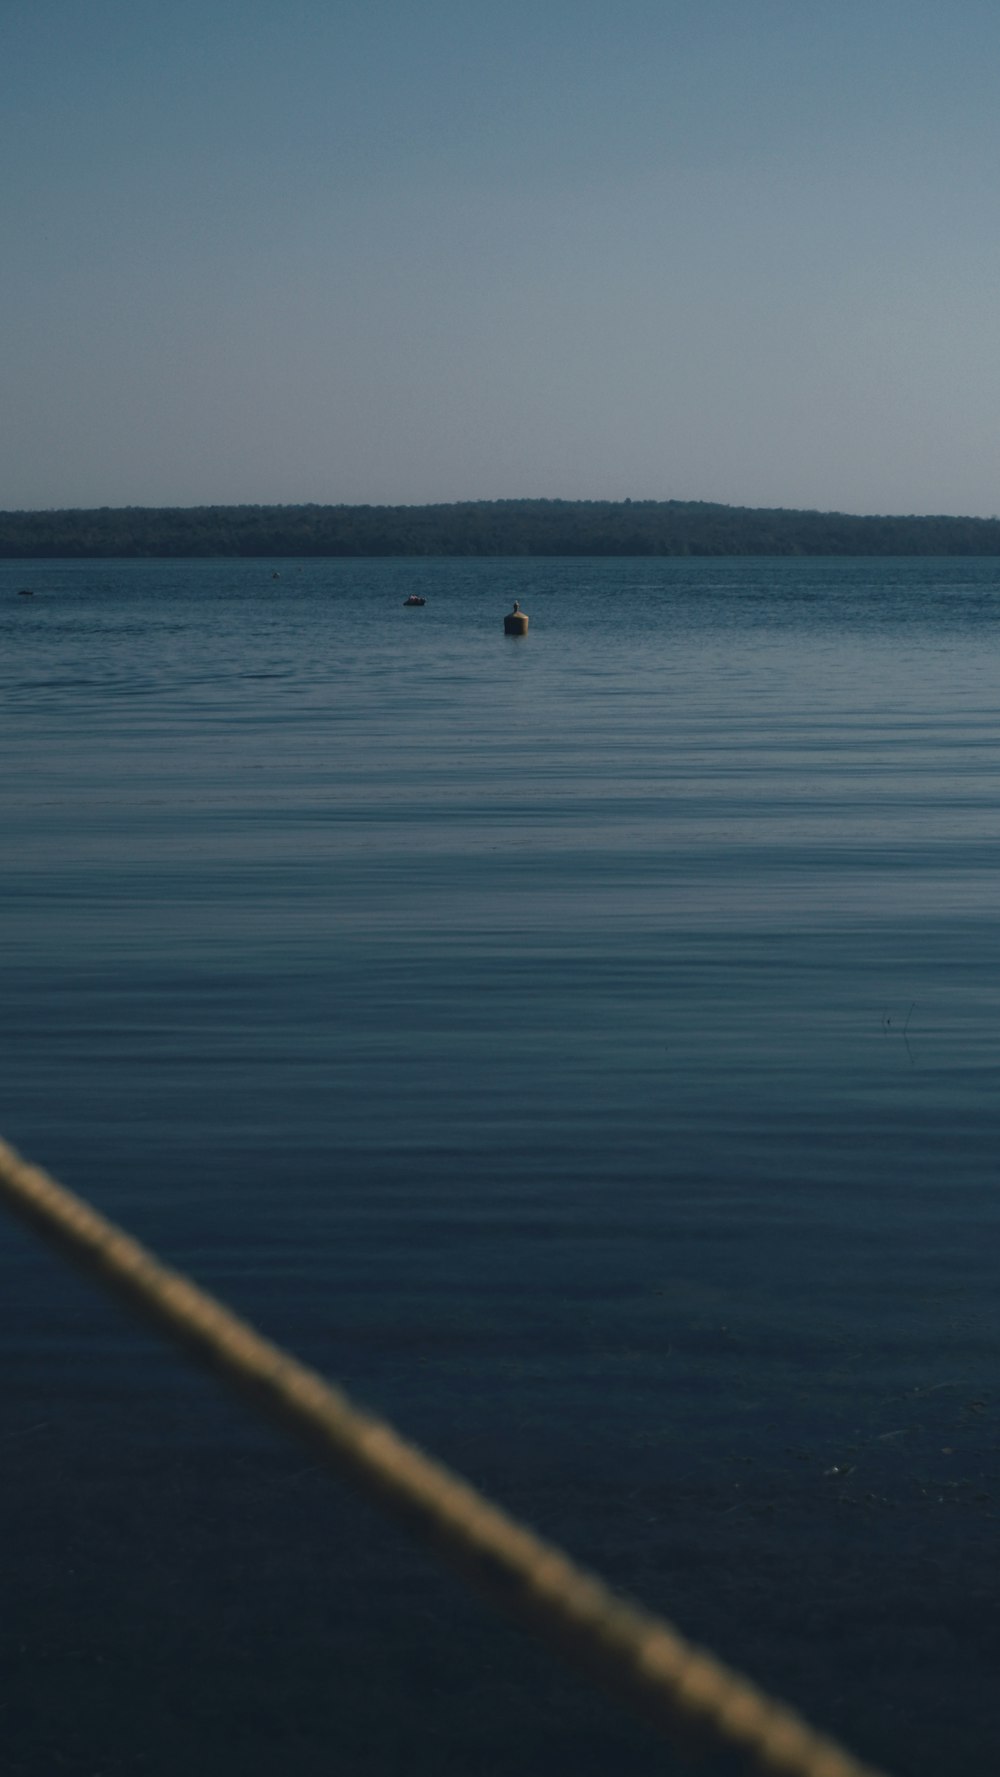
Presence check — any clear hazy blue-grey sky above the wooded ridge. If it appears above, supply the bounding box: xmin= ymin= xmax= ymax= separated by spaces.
xmin=0 ymin=0 xmax=1000 ymax=515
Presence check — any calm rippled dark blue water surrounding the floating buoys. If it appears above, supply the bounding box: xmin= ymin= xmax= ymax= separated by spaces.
xmin=0 ymin=562 xmax=1000 ymax=1777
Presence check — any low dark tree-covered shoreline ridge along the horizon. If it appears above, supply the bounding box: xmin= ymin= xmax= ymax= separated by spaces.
xmin=0 ymin=499 xmax=1000 ymax=560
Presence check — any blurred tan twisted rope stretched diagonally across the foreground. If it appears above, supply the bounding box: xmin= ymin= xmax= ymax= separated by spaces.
xmin=0 ymin=1141 xmax=891 ymax=1777
